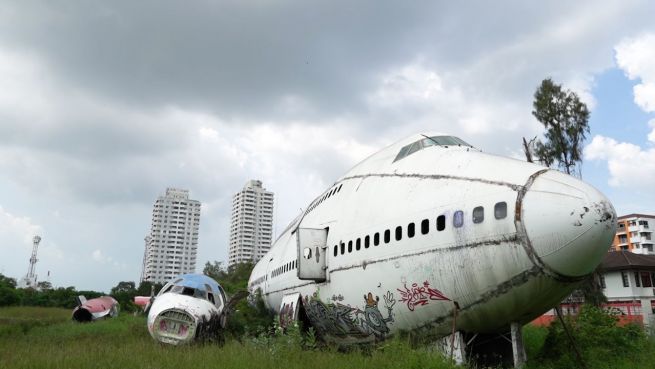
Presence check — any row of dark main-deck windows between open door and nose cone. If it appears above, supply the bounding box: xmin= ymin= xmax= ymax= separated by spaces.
xmin=332 ymin=201 xmax=507 ymax=256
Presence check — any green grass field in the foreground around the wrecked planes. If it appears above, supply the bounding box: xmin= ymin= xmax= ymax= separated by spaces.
xmin=0 ymin=308 xmax=655 ymax=369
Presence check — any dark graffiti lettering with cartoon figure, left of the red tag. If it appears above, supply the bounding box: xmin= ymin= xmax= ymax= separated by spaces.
xmin=303 ymin=291 xmax=396 ymax=338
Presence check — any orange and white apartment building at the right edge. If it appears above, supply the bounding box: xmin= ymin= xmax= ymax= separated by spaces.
xmin=610 ymin=214 xmax=655 ymax=254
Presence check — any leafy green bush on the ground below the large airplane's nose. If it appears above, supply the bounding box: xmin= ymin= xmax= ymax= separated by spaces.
xmin=538 ymin=305 xmax=649 ymax=368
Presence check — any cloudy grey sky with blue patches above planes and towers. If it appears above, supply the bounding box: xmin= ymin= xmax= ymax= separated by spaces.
xmin=0 ymin=0 xmax=655 ymax=291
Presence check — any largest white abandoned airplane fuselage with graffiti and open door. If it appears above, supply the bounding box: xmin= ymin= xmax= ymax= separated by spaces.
xmin=249 ymin=135 xmax=616 ymax=343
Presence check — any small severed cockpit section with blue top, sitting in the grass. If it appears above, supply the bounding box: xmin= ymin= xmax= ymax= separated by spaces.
xmin=148 ymin=274 xmax=227 ymax=345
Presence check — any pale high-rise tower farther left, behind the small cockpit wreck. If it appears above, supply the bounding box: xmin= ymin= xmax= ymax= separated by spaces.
xmin=141 ymin=188 xmax=200 ymax=283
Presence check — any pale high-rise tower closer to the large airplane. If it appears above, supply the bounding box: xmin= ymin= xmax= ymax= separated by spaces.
xmin=228 ymin=180 xmax=273 ymax=265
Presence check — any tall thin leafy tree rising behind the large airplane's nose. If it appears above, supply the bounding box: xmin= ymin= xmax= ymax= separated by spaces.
xmin=524 ymin=78 xmax=589 ymax=174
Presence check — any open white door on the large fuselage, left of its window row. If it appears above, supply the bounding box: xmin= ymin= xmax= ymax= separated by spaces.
xmin=296 ymin=228 xmax=328 ymax=282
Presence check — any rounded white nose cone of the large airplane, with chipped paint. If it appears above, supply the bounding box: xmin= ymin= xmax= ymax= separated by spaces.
xmin=518 ymin=170 xmax=616 ymax=277
